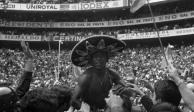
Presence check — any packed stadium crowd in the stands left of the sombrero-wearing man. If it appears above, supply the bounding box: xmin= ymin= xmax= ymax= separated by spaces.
xmin=1 ymin=49 xmax=73 ymax=88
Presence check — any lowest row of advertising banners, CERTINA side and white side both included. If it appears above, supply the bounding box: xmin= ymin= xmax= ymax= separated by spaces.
xmin=0 ymin=27 xmax=194 ymax=42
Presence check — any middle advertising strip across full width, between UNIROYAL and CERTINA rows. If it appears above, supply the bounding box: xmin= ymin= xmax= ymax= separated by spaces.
xmin=0 ymin=11 xmax=194 ymax=28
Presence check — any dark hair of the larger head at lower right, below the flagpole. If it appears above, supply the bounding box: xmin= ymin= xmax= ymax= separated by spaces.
xmin=154 ymin=80 xmax=181 ymax=106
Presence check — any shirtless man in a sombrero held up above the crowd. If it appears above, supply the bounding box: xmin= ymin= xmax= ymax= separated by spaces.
xmin=71 ymin=36 xmax=125 ymax=111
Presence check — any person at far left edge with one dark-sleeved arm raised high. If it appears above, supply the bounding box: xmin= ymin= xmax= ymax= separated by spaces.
xmin=0 ymin=42 xmax=33 ymax=112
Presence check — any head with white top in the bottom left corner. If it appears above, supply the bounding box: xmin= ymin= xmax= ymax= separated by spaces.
xmin=0 ymin=87 xmax=17 ymax=112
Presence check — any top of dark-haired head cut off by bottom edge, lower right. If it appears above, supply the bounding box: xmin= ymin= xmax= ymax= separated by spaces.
xmin=150 ymin=102 xmax=181 ymax=112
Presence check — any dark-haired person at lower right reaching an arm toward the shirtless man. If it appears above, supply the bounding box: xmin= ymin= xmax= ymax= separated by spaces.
xmin=126 ymin=80 xmax=181 ymax=112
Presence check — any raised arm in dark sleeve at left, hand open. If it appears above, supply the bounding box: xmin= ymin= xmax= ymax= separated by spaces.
xmin=16 ymin=41 xmax=34 ymax=98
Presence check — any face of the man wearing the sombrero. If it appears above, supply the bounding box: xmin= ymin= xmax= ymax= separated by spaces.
xmin=92 ymin=52 xmax=107 ymax=68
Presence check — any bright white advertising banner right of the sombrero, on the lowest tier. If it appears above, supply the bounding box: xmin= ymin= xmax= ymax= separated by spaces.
xmin=117 ymin=27 xmax=194 ymax=40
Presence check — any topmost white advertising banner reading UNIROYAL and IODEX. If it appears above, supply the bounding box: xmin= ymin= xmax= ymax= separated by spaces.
xmin=0 ymin=0 xmax=126 ymax=11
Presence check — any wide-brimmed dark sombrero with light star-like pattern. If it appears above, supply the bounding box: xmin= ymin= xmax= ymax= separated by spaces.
xmin=71 ymin=35 xmax=126 ymax=67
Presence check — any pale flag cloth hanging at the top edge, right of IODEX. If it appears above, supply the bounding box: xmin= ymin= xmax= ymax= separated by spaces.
xmin=130 ymin=0 xmax=147 ymax=13
